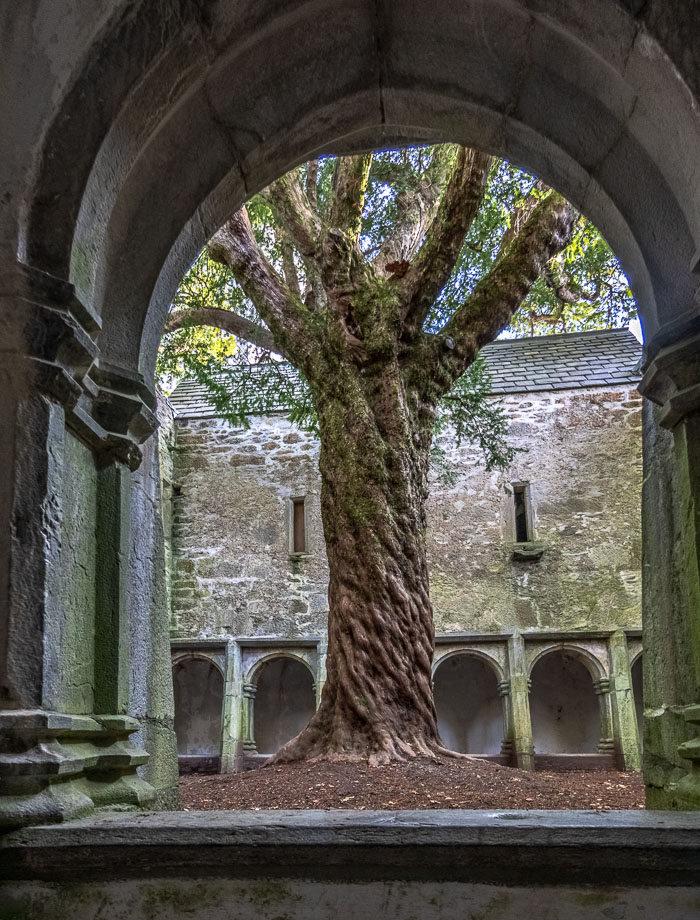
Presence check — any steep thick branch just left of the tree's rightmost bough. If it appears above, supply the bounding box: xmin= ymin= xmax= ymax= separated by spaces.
xmin=400 ymin=147 xmax=491 ymax=337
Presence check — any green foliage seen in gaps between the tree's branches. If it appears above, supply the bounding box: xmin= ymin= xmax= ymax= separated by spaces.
xmin=158 ymin=144 xmax=636 ymax=478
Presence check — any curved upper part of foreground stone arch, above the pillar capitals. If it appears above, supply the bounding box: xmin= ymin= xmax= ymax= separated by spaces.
xmin=9 ymin=0 xmax=700 ymax=388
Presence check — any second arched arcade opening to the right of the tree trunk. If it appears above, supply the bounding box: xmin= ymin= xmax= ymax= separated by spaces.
xmin=530 ymin=649 xmax=600 ymax=766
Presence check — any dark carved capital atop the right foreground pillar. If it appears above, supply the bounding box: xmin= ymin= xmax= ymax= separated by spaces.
xmin=639 ymin=329 xmax=700 ymax=428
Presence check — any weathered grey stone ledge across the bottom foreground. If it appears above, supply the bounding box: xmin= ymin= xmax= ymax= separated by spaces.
xmin=0 ymin=810 xmax=700 ymax=888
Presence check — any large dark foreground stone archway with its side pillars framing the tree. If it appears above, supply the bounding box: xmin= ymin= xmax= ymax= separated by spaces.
xmin=0 ymin=0 xmax=700 ymax=823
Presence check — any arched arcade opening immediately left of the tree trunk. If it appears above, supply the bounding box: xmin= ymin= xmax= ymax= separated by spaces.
xmin=254 ymin=655 xmax=316 ymax=755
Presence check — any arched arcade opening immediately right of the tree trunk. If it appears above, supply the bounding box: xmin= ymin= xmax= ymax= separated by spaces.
xmin=433 ymin=654 xmax=503 ymax=757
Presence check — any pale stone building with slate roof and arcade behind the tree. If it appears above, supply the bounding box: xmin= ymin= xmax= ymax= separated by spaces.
xmin=163 ymin=330 xmax=642 ymax=771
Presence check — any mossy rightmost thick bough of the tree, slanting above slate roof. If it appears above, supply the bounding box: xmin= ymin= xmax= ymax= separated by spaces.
xmin=430 ymin=191 xmax=579 ymax=392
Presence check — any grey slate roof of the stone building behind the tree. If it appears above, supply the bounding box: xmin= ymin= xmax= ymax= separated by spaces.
xmin=169 ymin=329 xmax=642 ymax=418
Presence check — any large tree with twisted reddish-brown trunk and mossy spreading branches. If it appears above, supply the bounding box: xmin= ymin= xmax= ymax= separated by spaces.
xmin=160 ymin=145 xmax=626 ymax=762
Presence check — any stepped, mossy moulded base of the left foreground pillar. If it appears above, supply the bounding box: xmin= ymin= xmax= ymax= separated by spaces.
xmin=0 ymin=710 xmax=155 ymax=828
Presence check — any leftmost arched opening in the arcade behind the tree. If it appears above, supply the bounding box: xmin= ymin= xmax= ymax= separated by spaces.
xmin=173 ymin=657 xmax=224 ymax=773
